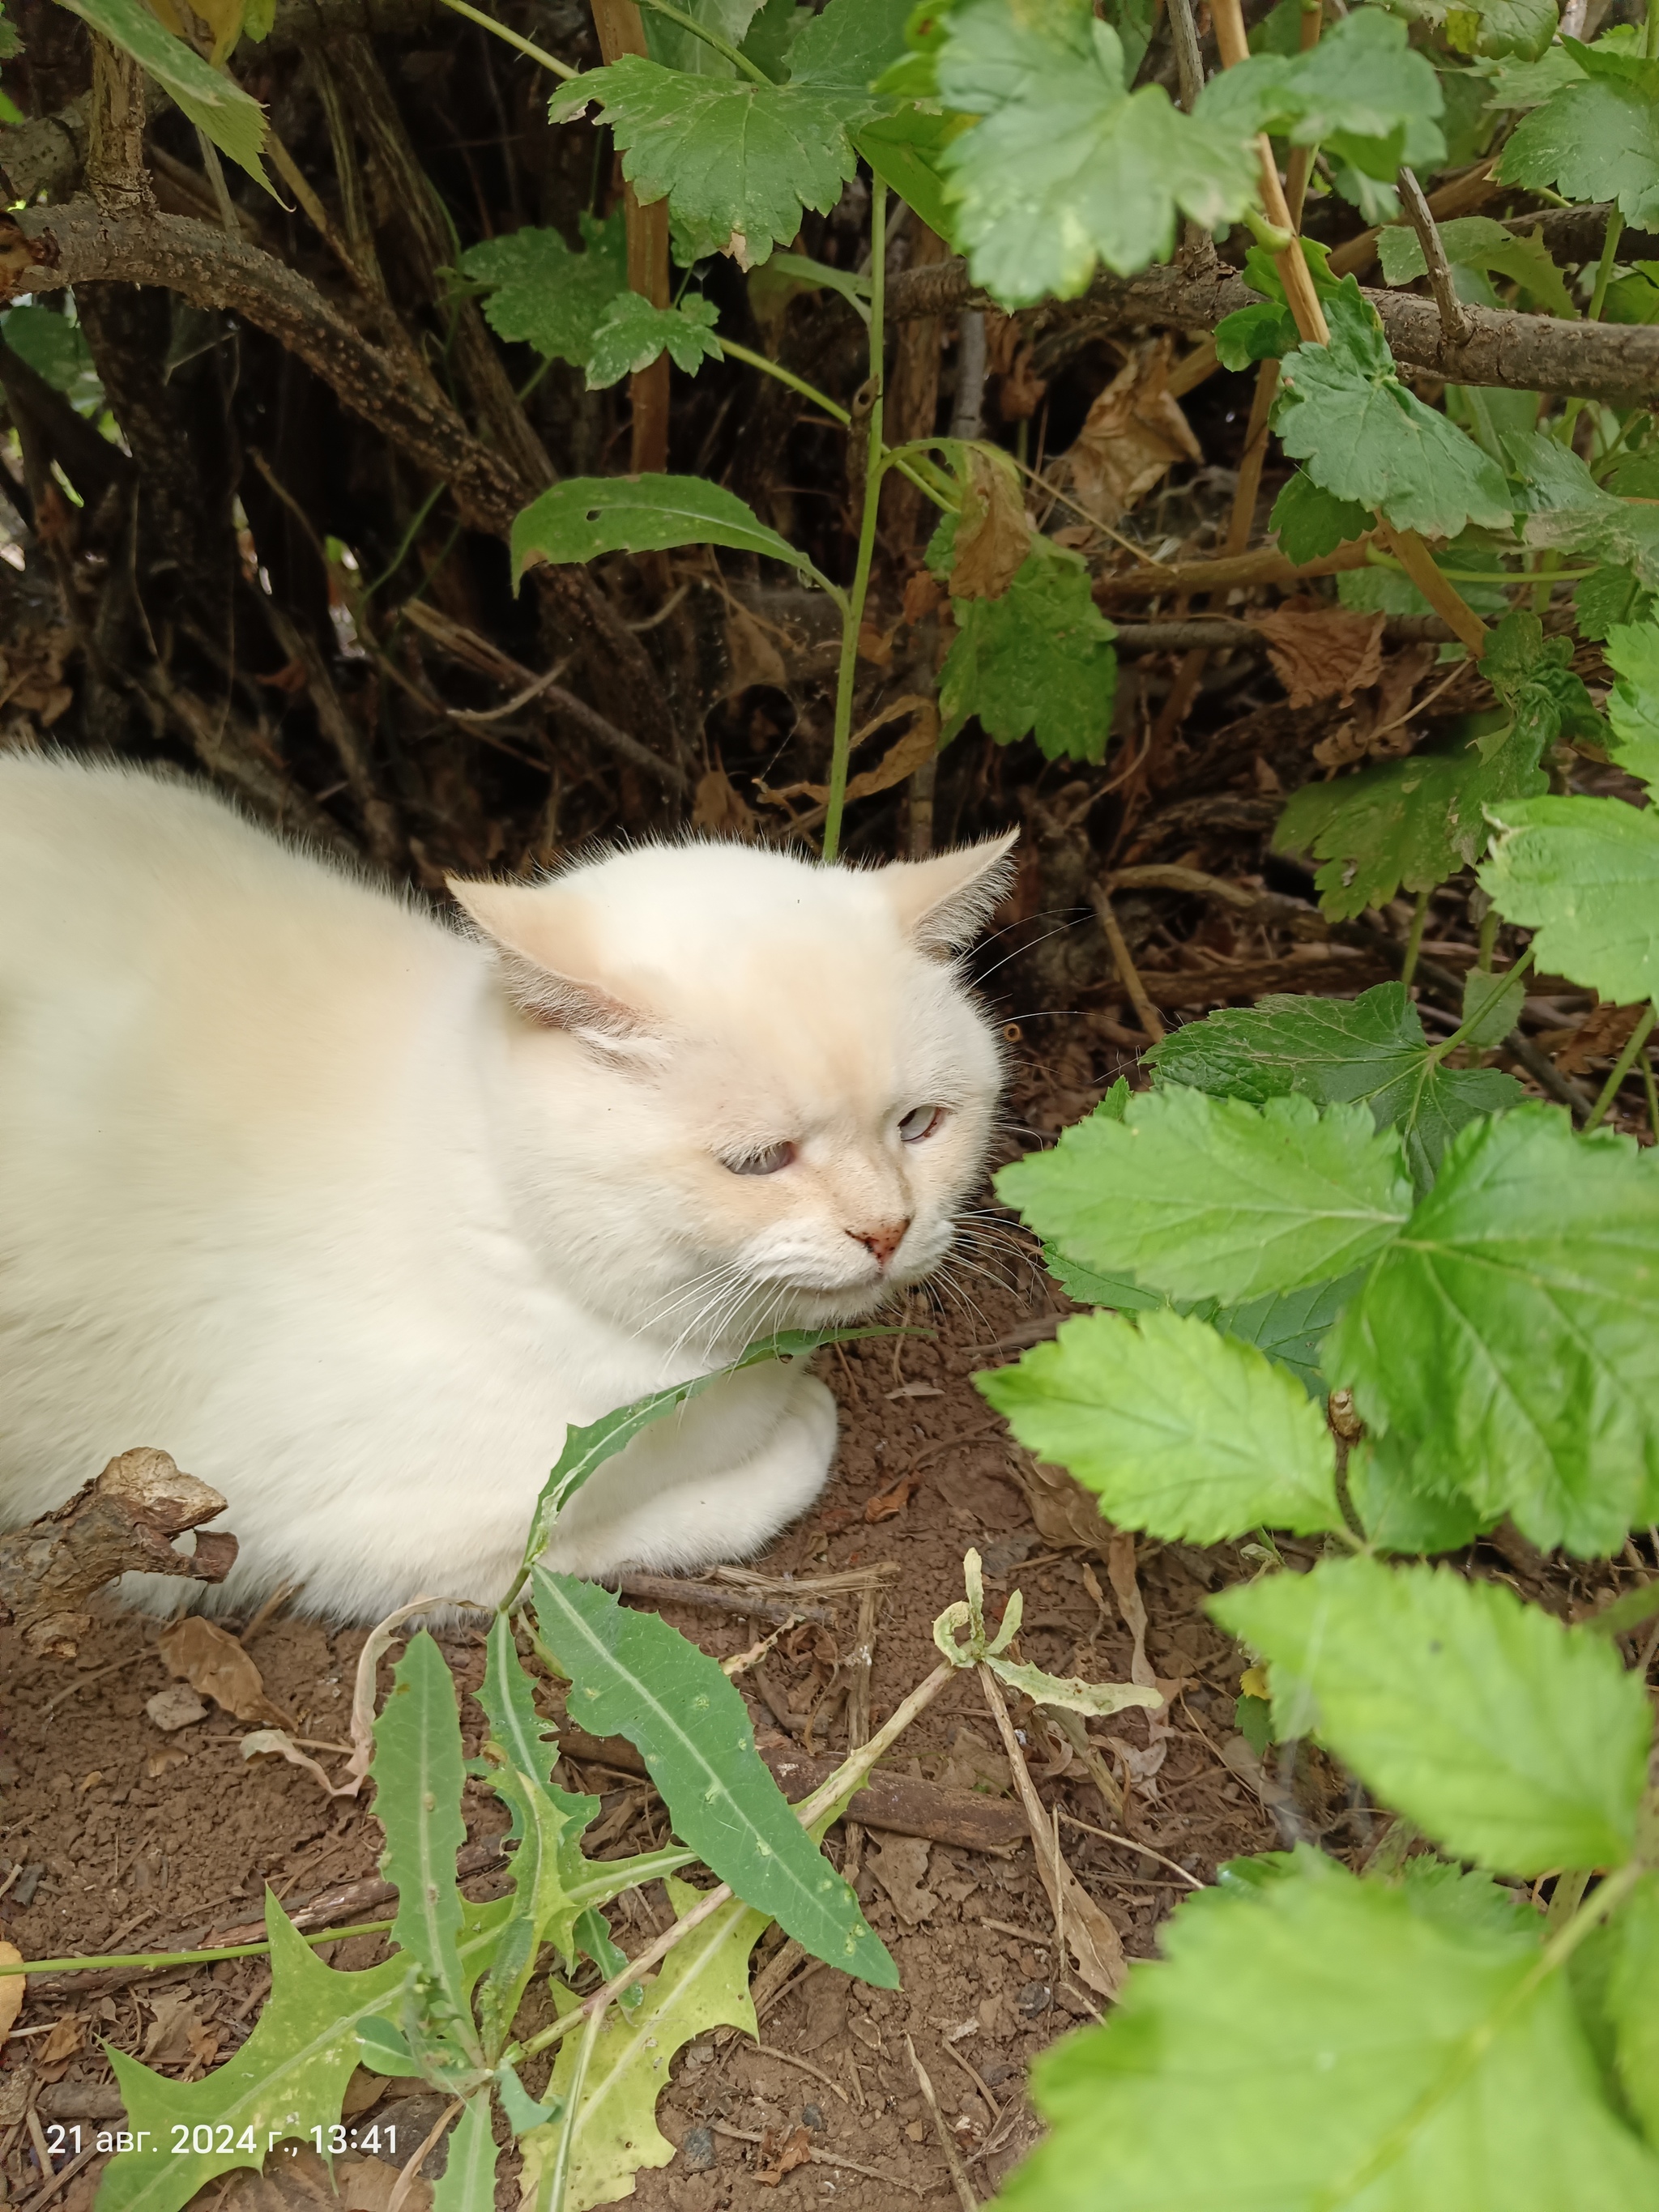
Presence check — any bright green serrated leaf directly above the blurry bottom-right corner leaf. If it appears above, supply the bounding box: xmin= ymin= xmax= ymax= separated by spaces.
xmin=1208 ymin=1559 xmax=1653 ymax=1876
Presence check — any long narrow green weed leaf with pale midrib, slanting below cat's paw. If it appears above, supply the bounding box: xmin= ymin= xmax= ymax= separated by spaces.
xmin=533 ymin=1566 xmax=898 ymax=1988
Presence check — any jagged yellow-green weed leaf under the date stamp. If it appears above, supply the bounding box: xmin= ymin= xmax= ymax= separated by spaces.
xmin=97 ymin=1891 xmax=409 ymax=2212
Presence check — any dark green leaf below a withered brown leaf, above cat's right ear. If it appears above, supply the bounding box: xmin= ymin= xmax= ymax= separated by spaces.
xmin=940 ymin=544 xmax=1117 ymax=761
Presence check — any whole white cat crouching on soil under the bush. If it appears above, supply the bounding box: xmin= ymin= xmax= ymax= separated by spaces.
xmin=0 ymin=757 xmax=1013 ymax=1619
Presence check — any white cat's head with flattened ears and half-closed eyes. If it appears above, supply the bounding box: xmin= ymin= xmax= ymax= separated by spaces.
xmin=451 ymin=836 xmax=1013 ymax=1349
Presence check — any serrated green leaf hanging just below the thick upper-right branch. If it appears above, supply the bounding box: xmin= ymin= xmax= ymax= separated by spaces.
xmin=1274 ymin=305 xmax=1511 ymax=538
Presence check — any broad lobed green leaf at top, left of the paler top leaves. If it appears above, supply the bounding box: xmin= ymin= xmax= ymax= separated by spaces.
xmin=548 ymin=46 xmax=883 ymax=267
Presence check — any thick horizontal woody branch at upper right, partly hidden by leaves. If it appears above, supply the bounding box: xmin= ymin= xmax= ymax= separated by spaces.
xmin=887 ymin=257 xmax=1659 ymax=405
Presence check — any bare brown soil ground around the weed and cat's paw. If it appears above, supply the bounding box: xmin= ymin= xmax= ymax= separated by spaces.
xmin=0 ymin=1044 xmax=1637 ymax=2212
